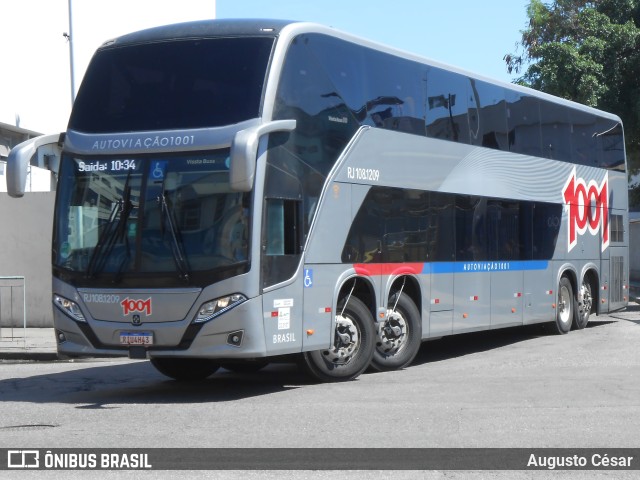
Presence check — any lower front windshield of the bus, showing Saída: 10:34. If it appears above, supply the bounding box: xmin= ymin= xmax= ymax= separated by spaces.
xmin=53 ymin=149 xmax=249 ymax=285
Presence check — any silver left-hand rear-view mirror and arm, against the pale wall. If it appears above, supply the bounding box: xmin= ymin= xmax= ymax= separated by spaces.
xmin=7 ymin=133 xmax=61 ymax=198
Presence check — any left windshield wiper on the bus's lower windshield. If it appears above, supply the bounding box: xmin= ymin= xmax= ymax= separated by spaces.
xmin=87 ymin=172 xmax=133 ymax=278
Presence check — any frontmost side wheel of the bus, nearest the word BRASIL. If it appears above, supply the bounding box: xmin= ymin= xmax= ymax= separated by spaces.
xmin=303 ymin=297 xmax=376 ymax=382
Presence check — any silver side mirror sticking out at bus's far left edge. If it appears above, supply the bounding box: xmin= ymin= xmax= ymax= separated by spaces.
xmin=6 ymin=133 xmax=62 ymax=198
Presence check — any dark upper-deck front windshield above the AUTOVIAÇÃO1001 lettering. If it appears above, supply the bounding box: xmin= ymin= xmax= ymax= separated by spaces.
xmin=69 ymin=37 xmax=274 ymax=133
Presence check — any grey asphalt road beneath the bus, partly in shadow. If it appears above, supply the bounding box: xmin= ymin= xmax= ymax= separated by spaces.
xmin=0 ymin=312 xmax=640 ymax=480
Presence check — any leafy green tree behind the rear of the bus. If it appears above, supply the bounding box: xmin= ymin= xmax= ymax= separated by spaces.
xmin=504 ymin=0 xmax=640 ymax=205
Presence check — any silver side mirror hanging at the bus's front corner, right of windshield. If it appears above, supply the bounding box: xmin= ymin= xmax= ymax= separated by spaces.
xmin=229 ymin=120 xmax=296 ymax=192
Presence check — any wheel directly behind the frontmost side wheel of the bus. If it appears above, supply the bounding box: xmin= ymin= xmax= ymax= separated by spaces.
xmin=371 ymin=293 xmax=422 ymax=371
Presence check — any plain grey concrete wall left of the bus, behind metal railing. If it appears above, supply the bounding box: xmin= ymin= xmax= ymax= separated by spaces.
xmin=0 ymin=192 xmax=55 ymax=328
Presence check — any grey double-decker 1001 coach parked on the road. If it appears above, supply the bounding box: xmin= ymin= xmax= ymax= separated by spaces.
xmin=8 ymin=20 xmax=628 ymax=381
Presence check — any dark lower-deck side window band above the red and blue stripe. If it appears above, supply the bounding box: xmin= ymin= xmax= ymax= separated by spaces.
xmin=342 ymin=187 xmax=562 ymax=263
